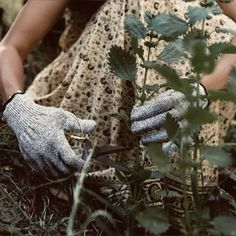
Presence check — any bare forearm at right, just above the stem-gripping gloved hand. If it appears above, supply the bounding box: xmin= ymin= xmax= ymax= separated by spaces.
xmin=201 ymin=36 xmax=236 ymax=90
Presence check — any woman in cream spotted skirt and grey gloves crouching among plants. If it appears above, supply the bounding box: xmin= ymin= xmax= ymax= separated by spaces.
xmin=0 ymin=0 xmax=236 ymax=229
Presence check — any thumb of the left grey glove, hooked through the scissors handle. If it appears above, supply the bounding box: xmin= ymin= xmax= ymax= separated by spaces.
xmin=62 ymin=111 xmax=96 ymax=134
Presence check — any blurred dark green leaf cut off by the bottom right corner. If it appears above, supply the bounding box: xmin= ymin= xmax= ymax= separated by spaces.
xmin=212 ymin=216 xmax=236 ymax=236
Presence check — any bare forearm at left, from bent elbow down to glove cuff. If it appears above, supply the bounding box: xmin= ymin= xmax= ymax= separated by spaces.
xmin=0 ymin=46 xmax=24 ymax=103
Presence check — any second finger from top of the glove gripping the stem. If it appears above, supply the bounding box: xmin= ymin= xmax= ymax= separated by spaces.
xmin=131 ymin=109 xmax=179 ymax=134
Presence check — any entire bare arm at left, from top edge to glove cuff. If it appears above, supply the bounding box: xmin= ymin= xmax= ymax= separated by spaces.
xmin=0 ymin=0 xmax=70 ymax=102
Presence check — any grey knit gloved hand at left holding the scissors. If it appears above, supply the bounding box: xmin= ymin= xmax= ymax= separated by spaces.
xmin=3 ymin=94 xmax=96 ymax=177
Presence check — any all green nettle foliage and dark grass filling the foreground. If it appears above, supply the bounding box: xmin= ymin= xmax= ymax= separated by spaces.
xmin=0 ymin=0 xmax=236 ymax=235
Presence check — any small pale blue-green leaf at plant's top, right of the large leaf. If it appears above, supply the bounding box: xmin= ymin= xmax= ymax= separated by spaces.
xmin=187 ymin=6 xmax=209 ymax=25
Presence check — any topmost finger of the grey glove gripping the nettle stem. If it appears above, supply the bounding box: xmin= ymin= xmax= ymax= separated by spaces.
xmin=131 ymin=91 xmax=184 ymax=121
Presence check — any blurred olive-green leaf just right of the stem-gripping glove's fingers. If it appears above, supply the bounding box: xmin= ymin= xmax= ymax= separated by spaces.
xmin=184 ymin=106 xmax=216 ymax=128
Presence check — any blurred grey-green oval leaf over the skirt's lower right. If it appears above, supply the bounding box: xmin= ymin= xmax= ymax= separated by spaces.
xmin=200 ymin=146 xmax=232 ymax=168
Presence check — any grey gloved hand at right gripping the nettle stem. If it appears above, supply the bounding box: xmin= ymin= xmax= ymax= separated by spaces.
xmin=131 ymin=84 xmax=208 ymax=147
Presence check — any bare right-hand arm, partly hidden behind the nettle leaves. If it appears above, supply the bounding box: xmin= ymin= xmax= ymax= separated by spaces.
xmin=201 ymin=0 xmax=236 ymax=90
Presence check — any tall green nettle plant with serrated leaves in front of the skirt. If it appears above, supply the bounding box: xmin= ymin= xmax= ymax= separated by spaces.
xmin=109 ymin=0 xmax=236 ymax=235
